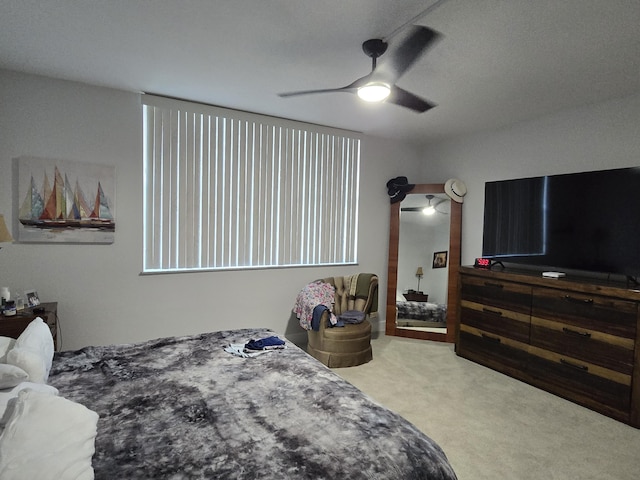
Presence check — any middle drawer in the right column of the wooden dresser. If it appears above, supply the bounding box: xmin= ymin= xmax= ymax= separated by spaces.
xmin=531 ymin=317 xmax=635 ymax=375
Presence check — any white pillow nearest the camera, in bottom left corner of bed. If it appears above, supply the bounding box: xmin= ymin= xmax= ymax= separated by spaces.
xmin=0 ymin=389 xmax=98 ymax=480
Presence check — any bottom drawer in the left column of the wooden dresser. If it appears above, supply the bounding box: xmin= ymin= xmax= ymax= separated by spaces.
xmin=456 ymin=325 xmax=528 ymax=378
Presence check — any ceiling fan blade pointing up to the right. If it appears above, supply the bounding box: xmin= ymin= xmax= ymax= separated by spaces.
xmin=374 ymin=25 xmax=440 ymax=84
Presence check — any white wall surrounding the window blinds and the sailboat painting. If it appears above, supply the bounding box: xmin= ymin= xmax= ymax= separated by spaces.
xmin=0 ymin=70 xmax=429 ymax=349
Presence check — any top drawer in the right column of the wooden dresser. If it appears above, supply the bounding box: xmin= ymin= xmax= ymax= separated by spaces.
xmin=531 ymin=287 xmax=638 ymax=339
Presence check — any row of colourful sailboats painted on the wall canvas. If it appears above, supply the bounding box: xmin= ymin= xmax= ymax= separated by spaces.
xmin=18 ymin=166 xmax=115 ymax=231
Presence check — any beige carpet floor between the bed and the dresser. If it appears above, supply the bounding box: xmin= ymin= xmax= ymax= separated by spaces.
xmin=334 ymin=335 xmax=640 ymax=480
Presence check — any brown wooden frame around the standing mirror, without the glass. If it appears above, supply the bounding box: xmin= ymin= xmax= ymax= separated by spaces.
xmin=385 ymin=183 xmax=462 ymax=343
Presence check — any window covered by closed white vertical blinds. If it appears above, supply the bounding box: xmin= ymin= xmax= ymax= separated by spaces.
xmin=142 ymin=95 xmax=360 ymax=273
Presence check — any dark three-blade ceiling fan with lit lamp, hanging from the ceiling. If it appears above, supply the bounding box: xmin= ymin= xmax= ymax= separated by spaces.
xmin=278 ymin=25 xmax=440 ymax=113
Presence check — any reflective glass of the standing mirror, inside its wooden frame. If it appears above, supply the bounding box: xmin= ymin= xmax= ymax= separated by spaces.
xmin=396 ymin=193 xmax=451 ymax=334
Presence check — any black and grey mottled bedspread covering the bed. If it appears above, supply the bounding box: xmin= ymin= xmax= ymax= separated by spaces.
xmin=32 ymin=329 xmax=456 ymax=480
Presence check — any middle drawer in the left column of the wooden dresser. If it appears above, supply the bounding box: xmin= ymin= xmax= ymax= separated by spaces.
xmin=460 ymin=300 xmax=530 ymax=343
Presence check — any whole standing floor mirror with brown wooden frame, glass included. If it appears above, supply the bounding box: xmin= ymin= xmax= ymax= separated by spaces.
xmin=385 ymin=184 xmax=462 ymax=343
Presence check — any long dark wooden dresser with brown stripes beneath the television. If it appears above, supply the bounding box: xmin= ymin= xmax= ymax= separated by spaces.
xmin=456 ymin=267 xmax=640 ymax=428
